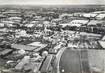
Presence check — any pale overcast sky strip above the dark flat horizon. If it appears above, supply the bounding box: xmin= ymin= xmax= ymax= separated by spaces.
xmin=0 ymin=0 xmax=105 ymax=5
